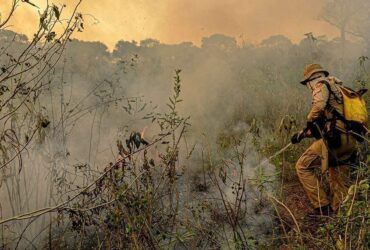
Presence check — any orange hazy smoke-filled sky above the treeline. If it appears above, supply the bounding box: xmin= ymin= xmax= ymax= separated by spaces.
xmin=0 ymin=0 xmax=337 ymax=49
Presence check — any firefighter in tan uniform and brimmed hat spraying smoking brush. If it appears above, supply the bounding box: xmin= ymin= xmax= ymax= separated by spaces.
xmin=291 ymin=64 xmax=356 ymax=215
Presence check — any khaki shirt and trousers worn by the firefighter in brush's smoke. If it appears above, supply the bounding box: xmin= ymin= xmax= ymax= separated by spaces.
xmin=296 ymin=77 xmax=356 ymax=211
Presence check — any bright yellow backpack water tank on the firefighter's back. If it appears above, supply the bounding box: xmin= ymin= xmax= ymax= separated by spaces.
xmin=339 ymin=86 xmax=368 ymax=125
